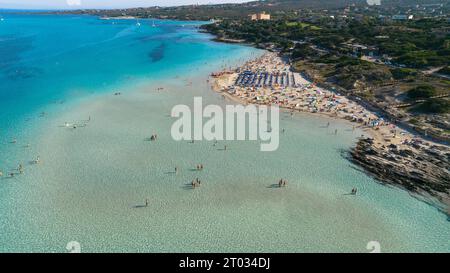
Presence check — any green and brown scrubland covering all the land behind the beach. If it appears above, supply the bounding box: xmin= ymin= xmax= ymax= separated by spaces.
xmin=57 ymin=0 xmax=450 ymax=139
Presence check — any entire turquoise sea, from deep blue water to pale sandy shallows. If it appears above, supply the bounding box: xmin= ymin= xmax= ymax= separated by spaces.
xmin=0 ymin=13 xmax=450 ymax=252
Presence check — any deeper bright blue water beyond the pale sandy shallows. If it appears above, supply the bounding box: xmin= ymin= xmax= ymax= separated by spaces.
xmin=0 ymin=13 xmax=250 ymax=130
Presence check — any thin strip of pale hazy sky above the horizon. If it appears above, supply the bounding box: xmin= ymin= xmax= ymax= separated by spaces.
xmin=0 ymin=0 xmax=248 ymax=9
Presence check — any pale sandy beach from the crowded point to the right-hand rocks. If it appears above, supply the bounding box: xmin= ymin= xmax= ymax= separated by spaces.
xmin=211 ymin=52 xmax=450 ymax=214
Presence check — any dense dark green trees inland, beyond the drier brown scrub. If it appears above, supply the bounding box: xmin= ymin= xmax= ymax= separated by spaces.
xmin=204 ymin=16 xmax=450 ymax=68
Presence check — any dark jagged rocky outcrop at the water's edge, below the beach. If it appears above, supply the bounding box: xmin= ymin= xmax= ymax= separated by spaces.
xmin=350 ymin=138 xmax=450 ymax=216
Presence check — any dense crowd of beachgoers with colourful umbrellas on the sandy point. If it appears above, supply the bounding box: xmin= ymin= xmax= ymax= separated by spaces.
xmin=212 ymin=52 xmax=424 ymax=150
